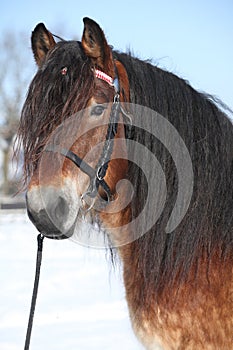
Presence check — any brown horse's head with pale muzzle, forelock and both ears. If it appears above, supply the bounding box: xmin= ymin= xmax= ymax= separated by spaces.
xmin=19 ymin=18 xmax=129 ymax=238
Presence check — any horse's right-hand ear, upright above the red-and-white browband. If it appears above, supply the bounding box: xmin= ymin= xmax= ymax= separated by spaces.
xmin=82 ymin=17 xmax=114 ymax=76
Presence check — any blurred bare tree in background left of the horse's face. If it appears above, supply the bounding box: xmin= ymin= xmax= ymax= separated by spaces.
xmin=0 ymin=32 xmax=33 ymax=195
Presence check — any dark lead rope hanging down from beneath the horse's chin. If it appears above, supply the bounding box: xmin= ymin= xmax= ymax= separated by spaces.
xmin=24 ymin=233 xmax=44 ymax=350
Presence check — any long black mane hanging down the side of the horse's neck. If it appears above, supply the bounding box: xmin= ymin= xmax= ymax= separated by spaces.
xmin=114 ymin=52 xmax=233 ymax=298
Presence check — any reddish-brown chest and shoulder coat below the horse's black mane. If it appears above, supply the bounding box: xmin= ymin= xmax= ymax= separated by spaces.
xmin=120 ymin=243 xmax=233 ymax=350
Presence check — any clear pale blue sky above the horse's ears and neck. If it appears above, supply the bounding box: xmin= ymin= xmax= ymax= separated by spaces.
xmin=0 ymin=0 xmax=233 ymax=109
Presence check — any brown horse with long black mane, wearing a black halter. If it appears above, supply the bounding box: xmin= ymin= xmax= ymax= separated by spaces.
xmin=18 ymin=18 xmax=233 ymax=350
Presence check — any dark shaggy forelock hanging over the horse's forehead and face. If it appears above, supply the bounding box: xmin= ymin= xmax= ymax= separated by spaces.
xmin=18 ymin=41 xmax=94 ymax=180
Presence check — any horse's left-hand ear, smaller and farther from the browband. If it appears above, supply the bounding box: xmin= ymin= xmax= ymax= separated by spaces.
xmin=31 ymin=23 xmax=56 ymax=67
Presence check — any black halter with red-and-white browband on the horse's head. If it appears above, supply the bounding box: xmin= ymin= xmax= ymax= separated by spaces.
xmin=45 ymin=65 xmax=132 ymax=208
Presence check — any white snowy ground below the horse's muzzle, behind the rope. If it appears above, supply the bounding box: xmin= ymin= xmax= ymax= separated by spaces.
xmin=0 ymin=212 xmax=143 ymax=350
